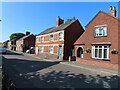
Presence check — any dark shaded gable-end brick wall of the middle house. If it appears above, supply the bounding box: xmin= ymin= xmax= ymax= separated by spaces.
xmin=64 ymin=20 xmax=84 ymax=60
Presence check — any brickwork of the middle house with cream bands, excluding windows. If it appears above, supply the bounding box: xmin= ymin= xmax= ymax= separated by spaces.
xmin=36 ymin=19 xmax=84 ymax=60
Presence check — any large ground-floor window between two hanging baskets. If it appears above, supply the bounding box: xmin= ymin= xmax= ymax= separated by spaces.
xmin=92 ymin=45 xmax=109 ymax=59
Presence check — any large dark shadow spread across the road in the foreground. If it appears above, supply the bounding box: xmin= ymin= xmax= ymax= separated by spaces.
xmin=3 ymin=57 xmax=120 ymax=89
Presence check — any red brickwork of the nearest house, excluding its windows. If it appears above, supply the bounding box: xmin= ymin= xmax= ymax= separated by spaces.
xmin=74 ymin=11 xmax=119 ymax=69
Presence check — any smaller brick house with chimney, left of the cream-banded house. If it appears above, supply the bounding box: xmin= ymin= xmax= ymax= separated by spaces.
xmin=16 ymin=32 xmax=35 ymax=52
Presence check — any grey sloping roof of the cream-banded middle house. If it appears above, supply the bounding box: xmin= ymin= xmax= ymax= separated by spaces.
xmin=38 ymin=20 xmax=76 ymax=35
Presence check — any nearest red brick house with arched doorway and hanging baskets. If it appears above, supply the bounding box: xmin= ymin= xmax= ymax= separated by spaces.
xmin=74 ymin=6 xmax=120 ymax=69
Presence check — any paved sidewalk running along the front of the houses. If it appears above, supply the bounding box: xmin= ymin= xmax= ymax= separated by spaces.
xmin=7 ymin=51 xmax=120 ymax=76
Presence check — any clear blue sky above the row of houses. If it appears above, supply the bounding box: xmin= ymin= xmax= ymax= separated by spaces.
xmin=0 ymin=2 xmax=118 ymax=42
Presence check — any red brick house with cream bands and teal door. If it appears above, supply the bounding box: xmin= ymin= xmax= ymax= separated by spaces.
xmin=36 ymin=17 xmax=84 ymax=60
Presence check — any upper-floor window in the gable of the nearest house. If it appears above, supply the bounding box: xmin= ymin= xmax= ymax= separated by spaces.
xmin=94 ymin=26 xmax=107 ymax=37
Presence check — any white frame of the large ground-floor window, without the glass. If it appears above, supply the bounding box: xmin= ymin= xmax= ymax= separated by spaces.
xmin=92 ymin=45 xmax=109 ymax=59
